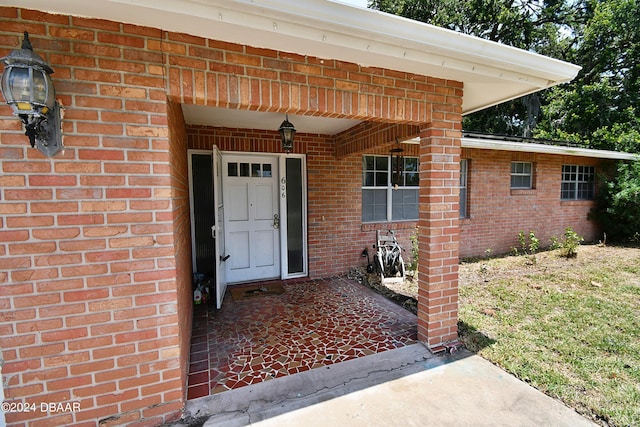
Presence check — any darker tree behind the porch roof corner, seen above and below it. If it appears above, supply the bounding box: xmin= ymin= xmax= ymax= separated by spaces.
xmin=371 ymin=0 xmax=586 ymax=136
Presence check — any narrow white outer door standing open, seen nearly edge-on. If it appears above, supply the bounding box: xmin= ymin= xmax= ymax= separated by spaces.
xmin=211 ymin=145 xmax=229 ymax=309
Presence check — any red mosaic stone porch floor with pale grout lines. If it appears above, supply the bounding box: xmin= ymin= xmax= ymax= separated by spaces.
xmin=187 ymin=276 xmax=417 ymax=400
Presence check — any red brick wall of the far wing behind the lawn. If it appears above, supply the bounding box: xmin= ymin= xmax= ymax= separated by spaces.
xmin=460 ymin=148 xmax=602 ymax=257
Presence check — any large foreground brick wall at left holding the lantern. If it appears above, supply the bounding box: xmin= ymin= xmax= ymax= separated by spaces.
xmin=0 ymin=8 xmax=182 ymax=426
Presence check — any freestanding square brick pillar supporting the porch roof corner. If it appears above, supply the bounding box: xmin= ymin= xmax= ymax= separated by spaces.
xmin=418 ymin=122 xmax=461 ymax=349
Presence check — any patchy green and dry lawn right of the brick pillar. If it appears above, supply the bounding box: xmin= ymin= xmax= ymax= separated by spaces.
xmin=459 ymin=246 xmax=640 ymax=426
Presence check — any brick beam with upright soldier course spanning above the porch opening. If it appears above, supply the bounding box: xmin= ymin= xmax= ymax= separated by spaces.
xmin=166 ymin=38 xmax=436 ymax=124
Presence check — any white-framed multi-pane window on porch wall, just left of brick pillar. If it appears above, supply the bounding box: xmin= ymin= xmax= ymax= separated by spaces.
xmin=362 ymin=156 xmax=420 ymax=222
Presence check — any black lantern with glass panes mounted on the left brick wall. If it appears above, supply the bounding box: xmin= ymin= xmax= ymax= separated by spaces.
xmin=0 ymin=31 xmax=63 ymax=157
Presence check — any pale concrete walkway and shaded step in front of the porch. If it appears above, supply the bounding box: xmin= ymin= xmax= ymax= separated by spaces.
xmin=175 ymin=344 xmax=596 ymax=427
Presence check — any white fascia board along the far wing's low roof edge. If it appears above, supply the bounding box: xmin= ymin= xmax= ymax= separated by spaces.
xmin=461 ymin=137 xmax=640 ymax=160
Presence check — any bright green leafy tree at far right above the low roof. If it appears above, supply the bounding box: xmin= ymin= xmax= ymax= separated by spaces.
xmin=536 ymin=0 xmax=640 ymax=152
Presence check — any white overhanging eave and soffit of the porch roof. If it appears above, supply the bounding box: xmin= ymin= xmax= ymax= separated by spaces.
xmin=6 ymin=0 xmax=580 ymax=114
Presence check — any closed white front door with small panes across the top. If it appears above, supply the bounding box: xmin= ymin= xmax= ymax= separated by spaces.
xmin=222 ymin=155 xmax=280 ymax=283
